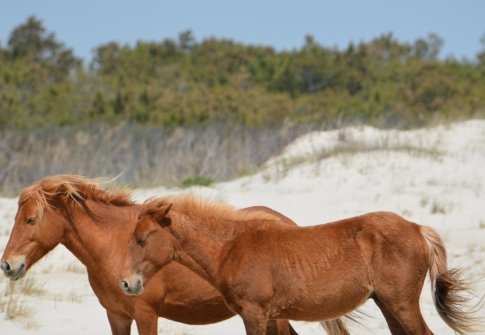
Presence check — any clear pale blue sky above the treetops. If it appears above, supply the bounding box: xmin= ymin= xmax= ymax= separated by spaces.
xmin=0 ymin=0 xmax=485 ymax=60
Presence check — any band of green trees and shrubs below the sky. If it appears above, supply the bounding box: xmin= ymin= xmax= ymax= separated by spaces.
xmin=0 ymin=17 xmax=485 ymax=129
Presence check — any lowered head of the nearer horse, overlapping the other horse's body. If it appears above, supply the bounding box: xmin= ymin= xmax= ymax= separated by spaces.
xmin=120 ymin=201 xmax=175 ymax=295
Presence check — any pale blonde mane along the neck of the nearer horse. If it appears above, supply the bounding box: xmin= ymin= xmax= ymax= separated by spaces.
xmin=144 ymin=194 xmax=280 ymax=226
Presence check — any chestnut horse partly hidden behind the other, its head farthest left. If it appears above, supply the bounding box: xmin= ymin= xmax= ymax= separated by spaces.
xmin=1 ymin=175 xmax=348 ymax=335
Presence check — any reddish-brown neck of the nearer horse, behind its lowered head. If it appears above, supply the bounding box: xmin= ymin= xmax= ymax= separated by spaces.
xmin=170 ymin=216 xmax=238 ymax=283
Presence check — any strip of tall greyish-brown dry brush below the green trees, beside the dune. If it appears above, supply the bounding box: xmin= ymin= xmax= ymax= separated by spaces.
xmin=0 ymin=124 xmax=310 ymax=195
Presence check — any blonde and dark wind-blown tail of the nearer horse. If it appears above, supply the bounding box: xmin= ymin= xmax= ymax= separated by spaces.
xmin=419 ymin=226 xmax=483 ymax=334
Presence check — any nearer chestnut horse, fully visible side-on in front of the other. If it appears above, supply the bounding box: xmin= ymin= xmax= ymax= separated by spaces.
xmin=121 ymin=196 xmax=480 ymax=335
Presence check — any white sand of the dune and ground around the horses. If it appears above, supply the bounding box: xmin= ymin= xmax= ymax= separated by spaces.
xmin=0 ymin=121 xmax=485 ymax=335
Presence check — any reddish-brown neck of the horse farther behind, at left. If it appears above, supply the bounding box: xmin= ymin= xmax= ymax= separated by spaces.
xmin=63 ymin=202 xmax=135 ymax=271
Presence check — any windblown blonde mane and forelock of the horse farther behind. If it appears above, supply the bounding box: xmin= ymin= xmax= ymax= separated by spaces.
xmin=19 ymin=174 xmax=134 ymax=216
